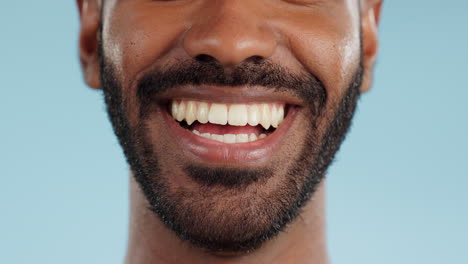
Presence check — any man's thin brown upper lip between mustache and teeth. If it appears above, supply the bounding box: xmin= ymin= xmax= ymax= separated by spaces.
xmin=158 ymin=85 xmax=302 ymax=106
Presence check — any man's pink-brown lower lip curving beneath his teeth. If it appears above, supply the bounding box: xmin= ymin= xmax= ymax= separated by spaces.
xmin=162 ymin=107 xmax=297 ymax=165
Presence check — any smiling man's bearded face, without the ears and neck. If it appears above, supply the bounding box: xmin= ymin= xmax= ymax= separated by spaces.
xmin=80 ymin=0 xmax=378 ymax=254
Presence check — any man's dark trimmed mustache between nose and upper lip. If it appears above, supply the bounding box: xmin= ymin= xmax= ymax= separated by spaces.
xmin=137 ymin=57 xmax=327 ymax=110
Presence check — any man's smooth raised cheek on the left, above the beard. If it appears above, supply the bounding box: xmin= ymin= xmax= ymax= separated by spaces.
xmin=103 ymin=1 xmax=191 ymax=86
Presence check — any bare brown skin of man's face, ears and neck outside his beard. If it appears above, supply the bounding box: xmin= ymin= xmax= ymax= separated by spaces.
xmin=77 ymin=0 xmax=382 ymax=264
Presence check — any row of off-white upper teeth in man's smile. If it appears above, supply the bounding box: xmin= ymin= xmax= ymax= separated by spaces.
xmin=171 ymin=100 xmax=284 ymax=129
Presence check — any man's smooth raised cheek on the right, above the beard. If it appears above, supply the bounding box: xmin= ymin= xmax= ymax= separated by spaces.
xmin=274 ymin=6 xmax=360 ymax=100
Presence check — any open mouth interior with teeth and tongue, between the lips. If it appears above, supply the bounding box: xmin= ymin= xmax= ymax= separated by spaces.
xmin=170 ymin=100 xmax=287 ymax=144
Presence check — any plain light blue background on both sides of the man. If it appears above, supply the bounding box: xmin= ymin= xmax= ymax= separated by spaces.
xmin=0 ymin=0 xmax=468 ymax=264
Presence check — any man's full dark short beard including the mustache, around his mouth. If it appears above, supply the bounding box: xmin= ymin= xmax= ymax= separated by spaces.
xmin=99 ymin=34 xmax=363 ymax=252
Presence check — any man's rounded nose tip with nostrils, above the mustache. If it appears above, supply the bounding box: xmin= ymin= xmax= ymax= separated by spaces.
xmin=183 ymin=13 xmax=277 ymax=66
